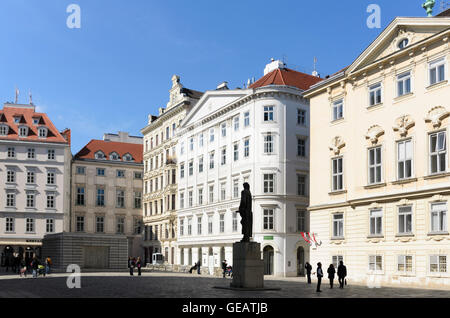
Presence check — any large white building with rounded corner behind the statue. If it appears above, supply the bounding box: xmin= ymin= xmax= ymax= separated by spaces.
xmin=177 ymin=61 xmax=321 ymax=276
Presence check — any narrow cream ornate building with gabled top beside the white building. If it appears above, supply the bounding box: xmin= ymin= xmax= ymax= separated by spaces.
xmin=141 ymin=75 xmax=202 ymax=264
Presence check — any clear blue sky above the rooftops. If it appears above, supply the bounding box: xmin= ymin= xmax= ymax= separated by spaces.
xmin=0 ymin=0 xmax=436 ymax=153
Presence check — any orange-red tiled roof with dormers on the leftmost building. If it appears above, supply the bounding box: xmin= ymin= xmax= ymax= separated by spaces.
xmin=0 ymin=104 xmax=68 ymax=143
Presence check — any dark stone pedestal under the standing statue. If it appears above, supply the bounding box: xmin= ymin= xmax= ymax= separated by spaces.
xmin=230 ymin=242 xmax=264 ymax=289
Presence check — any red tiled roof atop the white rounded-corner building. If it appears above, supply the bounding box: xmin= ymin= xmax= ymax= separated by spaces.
xmin=250 ymin=68 xmax=323 ymax=90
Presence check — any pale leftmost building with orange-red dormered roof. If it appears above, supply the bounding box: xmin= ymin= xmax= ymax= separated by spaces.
xmin=0 ymin=102 xmax=71 ymax=265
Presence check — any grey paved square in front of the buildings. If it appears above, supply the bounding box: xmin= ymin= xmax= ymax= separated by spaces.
xmin=0 ymin=272 xmax=450 ymax=298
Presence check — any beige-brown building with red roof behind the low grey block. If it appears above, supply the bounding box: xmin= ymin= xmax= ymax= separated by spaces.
xmin=68 ymin=132 xmax=143 ymax=260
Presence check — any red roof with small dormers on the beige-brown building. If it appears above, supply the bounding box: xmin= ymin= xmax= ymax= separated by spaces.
xmin=74 ymin=139 xmax=144 ymax=163
